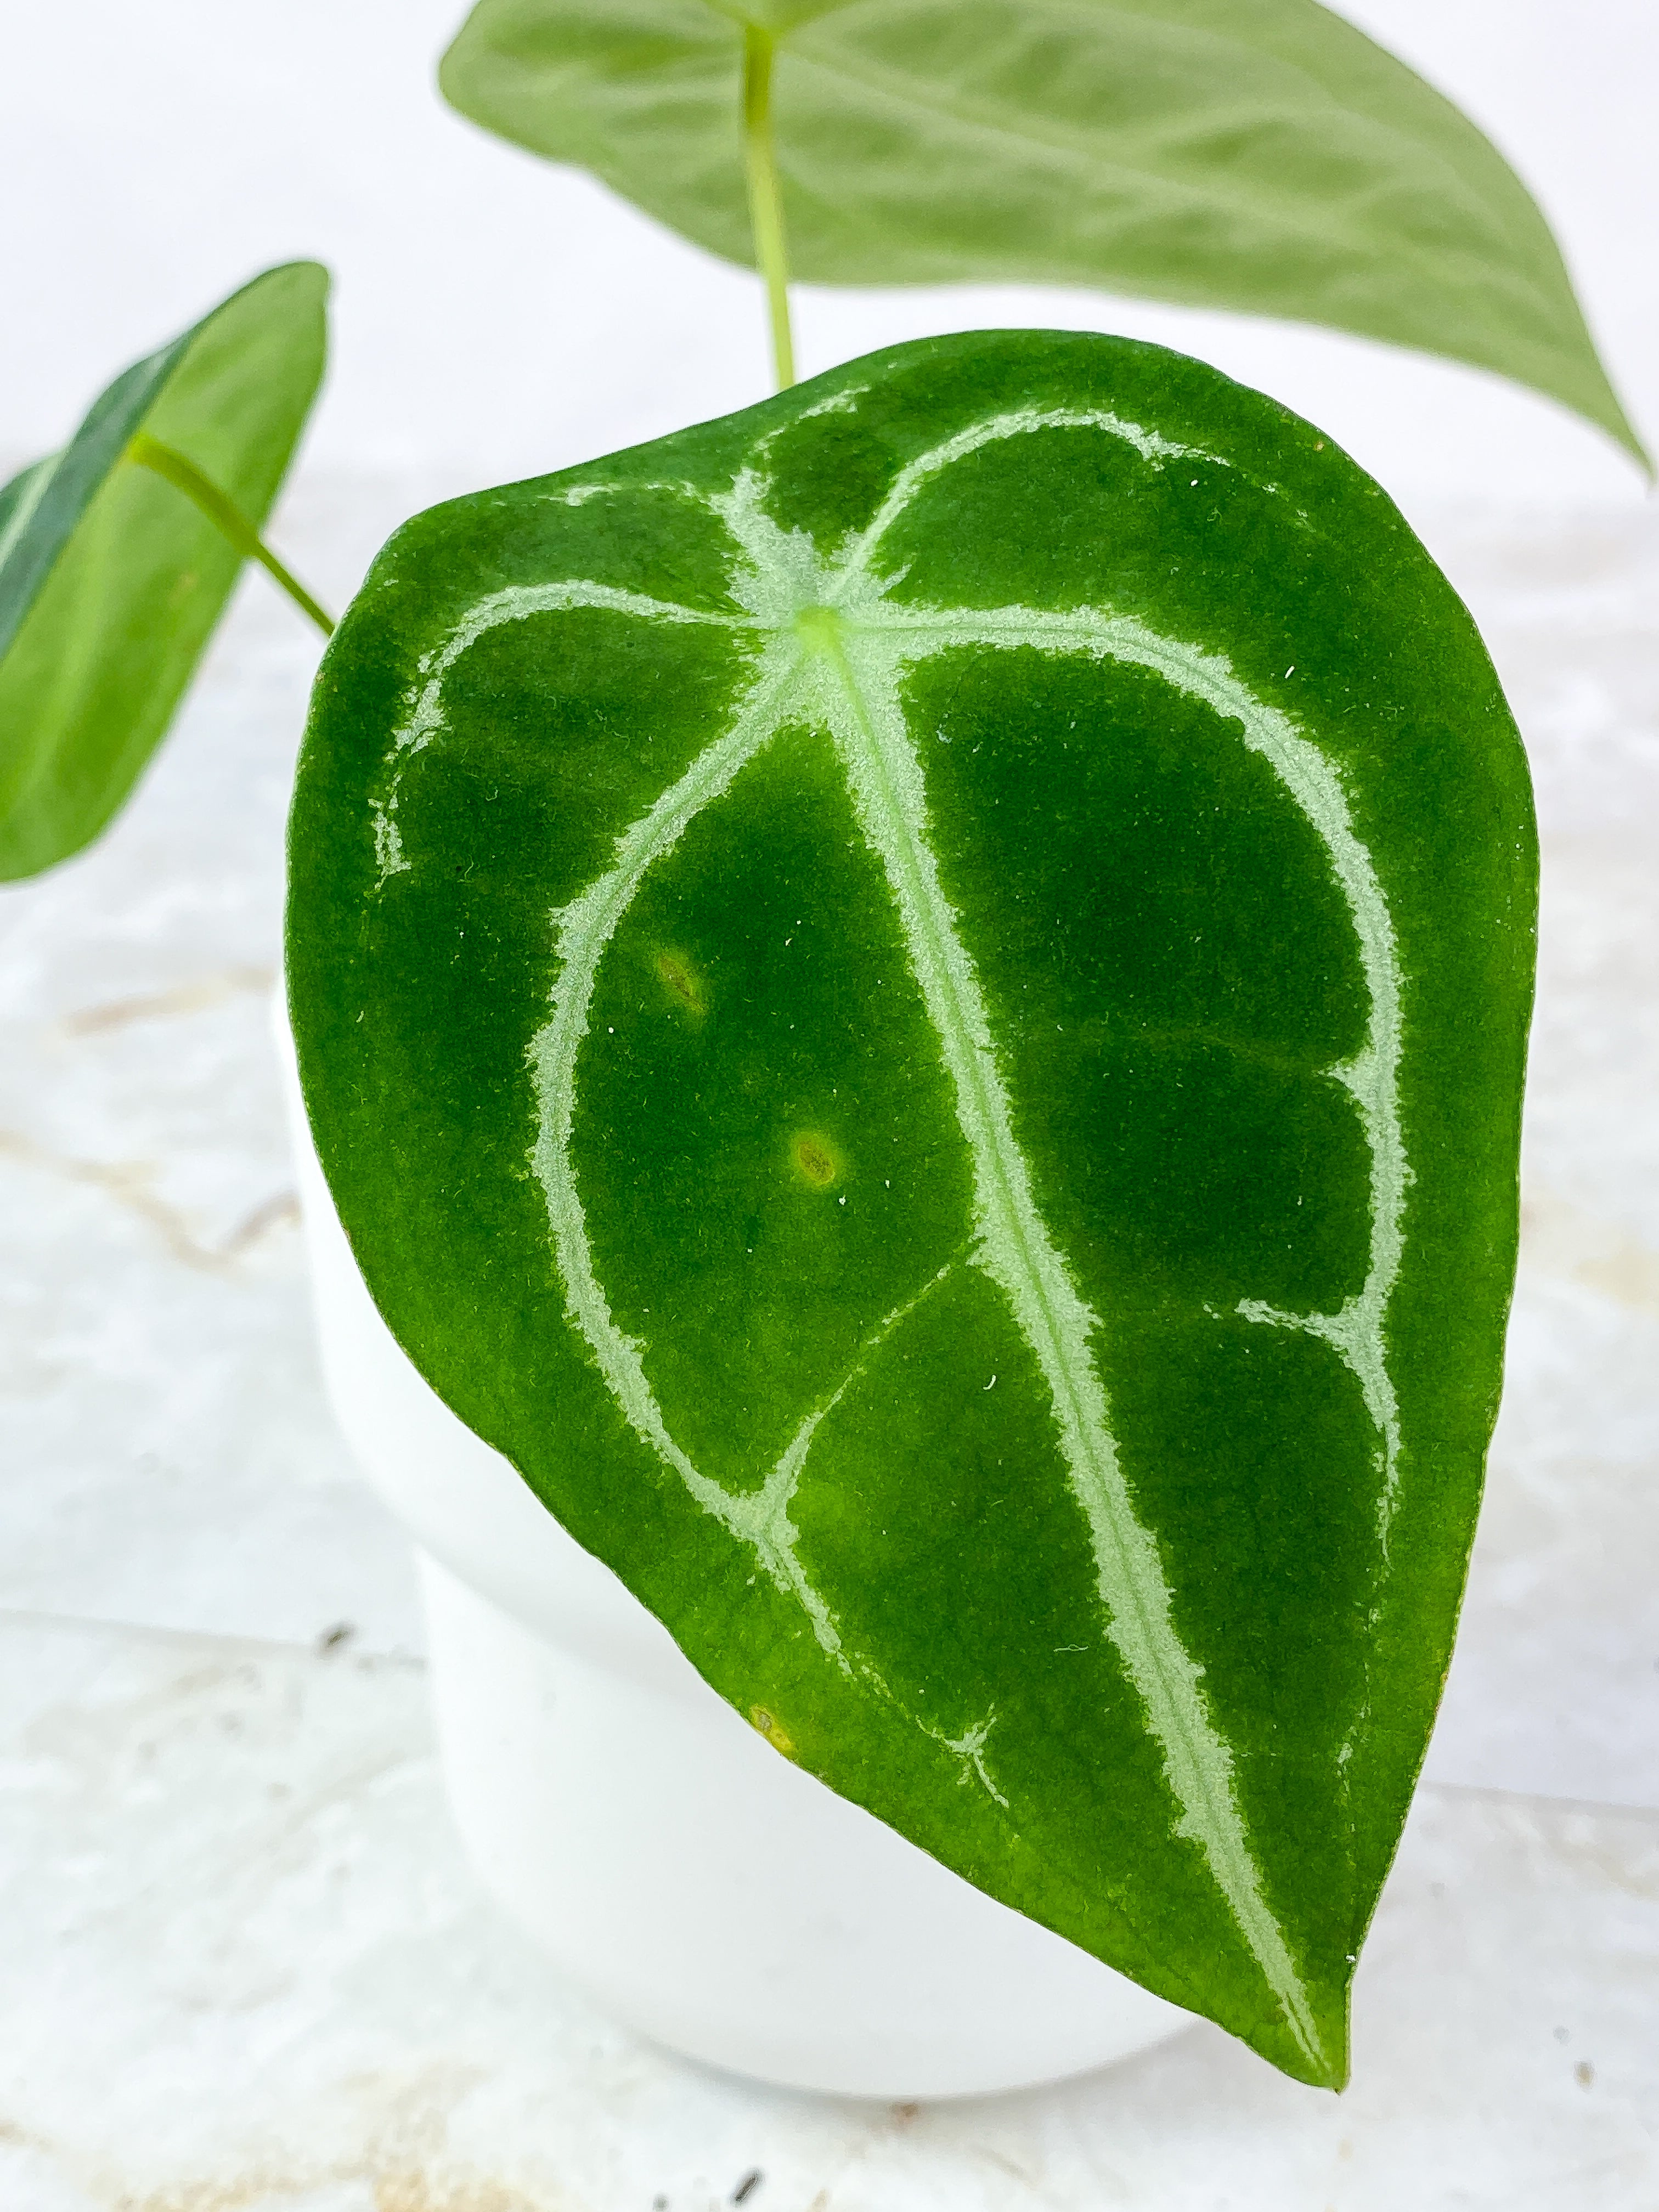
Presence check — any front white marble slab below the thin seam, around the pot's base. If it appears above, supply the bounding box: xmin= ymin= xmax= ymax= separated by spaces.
xmin=0 ymin=1621 xmax=1659 ymax=2212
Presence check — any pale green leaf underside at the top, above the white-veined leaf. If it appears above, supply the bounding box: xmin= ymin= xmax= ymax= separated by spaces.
xmin=438 ymin=0 xmax=1646 ymax=467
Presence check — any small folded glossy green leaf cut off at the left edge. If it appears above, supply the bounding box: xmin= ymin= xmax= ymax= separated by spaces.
xmin=0 ymin=261 xmax=328 ymax=878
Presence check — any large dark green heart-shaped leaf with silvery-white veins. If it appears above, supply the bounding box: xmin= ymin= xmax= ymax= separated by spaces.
xmin=287 ymin=334 xmax=1535 ymax=2081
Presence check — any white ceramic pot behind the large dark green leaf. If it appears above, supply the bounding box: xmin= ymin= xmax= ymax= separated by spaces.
xmin=276 ymin=1007 xmax=1190 ymax=2099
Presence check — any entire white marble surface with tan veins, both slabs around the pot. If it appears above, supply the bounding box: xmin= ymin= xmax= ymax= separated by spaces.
xmin=0 ymin=480 xmax=1659 ymax=2212
